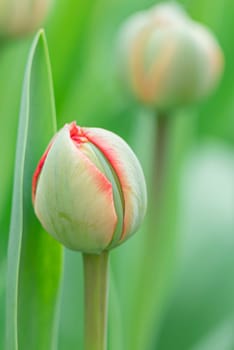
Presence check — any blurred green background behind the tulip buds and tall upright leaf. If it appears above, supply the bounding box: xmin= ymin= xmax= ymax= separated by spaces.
xmin=0 ymin=0 xmax=234 ymax=350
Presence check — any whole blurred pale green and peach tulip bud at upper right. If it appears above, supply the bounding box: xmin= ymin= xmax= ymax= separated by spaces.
xmin=119 ymin=3 xmax=223 ymax=109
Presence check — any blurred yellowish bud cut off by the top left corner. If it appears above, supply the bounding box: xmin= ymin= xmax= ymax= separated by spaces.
xmin=0 ymin=0 xmax=51 ymax=37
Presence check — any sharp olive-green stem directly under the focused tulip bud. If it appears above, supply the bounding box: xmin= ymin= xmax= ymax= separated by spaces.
xmin=83 ymin=251 xmax=109 ymax=350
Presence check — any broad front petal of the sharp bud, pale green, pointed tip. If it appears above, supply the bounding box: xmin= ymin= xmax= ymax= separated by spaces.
xmin=35 ymin=125 xmax=117 ymax=253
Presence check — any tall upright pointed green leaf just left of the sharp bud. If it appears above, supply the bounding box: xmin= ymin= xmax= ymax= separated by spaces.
xmin=6 ymin=31 xmax=61 ymax=350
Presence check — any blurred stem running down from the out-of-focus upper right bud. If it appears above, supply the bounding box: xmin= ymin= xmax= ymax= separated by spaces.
xmin=129 ymin=113 xmax=171 ymax=350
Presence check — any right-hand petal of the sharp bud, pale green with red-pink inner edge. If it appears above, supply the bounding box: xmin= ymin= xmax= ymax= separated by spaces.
xmin=82 ymin=128 xmax=147 ymax=241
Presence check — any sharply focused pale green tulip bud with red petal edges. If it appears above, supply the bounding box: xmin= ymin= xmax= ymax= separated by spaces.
xmin=32 ymin=122 xmax=147 ymax=254
